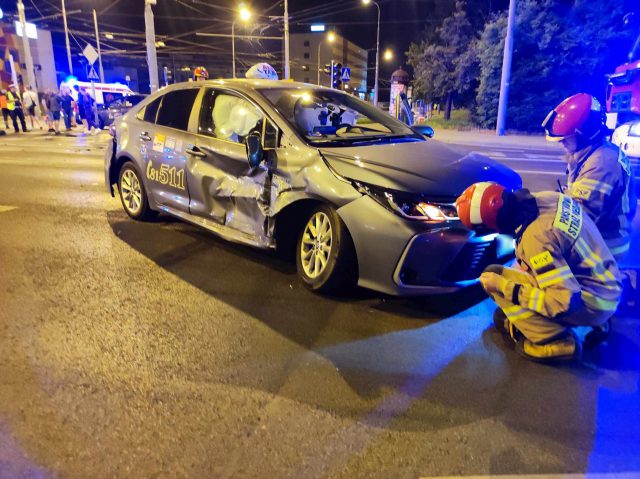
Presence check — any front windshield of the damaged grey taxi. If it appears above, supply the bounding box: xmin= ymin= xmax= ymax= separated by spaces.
xmin=261 ymin=88 xmax=422 ymax=146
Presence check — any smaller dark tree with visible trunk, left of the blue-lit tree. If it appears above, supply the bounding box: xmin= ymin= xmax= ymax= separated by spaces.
xmin=407 ymin=1 xmax=477 ymax=121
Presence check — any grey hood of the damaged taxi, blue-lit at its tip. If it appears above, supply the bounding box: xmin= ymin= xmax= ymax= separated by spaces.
xmin=320 ymin=140 xmax=522 ymax=197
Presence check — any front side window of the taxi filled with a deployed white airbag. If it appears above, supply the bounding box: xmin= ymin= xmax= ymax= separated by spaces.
xmin=198 ymin=89 xmax=264 ymax=143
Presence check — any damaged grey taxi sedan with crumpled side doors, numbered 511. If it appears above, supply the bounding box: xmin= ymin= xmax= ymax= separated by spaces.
xmin=105 ymin=80 xmax=521 ymax=295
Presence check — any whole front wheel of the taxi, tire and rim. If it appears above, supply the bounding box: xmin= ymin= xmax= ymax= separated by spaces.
xmin=296 ymin=205 xmax=358 ymax=293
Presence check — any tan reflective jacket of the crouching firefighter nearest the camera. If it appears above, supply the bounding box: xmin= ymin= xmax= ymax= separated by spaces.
xmin=502 ymin=192 xmax=622 ymax=321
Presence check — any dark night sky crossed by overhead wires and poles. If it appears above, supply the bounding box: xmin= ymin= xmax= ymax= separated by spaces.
xmin=0 ymin=0 xmax=507 ymax=82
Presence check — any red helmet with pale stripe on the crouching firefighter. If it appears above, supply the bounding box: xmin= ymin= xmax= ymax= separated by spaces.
xmin=456 ymin=182 xmax=505 ymax=231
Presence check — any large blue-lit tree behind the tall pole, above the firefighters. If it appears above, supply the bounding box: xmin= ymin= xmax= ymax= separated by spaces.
xmin=474 ymin=0 xmax=629 ymax=131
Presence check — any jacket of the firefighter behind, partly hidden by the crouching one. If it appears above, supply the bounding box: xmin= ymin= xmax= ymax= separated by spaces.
xmin=567 ymin=141 xmax=636 ymax=259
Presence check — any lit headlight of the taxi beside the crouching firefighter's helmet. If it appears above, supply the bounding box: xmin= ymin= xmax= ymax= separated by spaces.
xmin=353 ymin=181 xmax=458 ymax=223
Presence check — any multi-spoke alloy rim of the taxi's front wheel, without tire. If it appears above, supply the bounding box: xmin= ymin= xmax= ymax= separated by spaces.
xmin=300 ymin=211 xmax=333 ymax=279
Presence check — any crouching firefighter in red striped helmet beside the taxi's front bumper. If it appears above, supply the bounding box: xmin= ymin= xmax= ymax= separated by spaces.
xmin=456 ymin=183 xmax=622 ymax=362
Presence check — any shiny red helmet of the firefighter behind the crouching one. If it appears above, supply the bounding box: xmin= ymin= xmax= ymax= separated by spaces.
xmin=542 ymin=93 xmax=604 ymax=141
